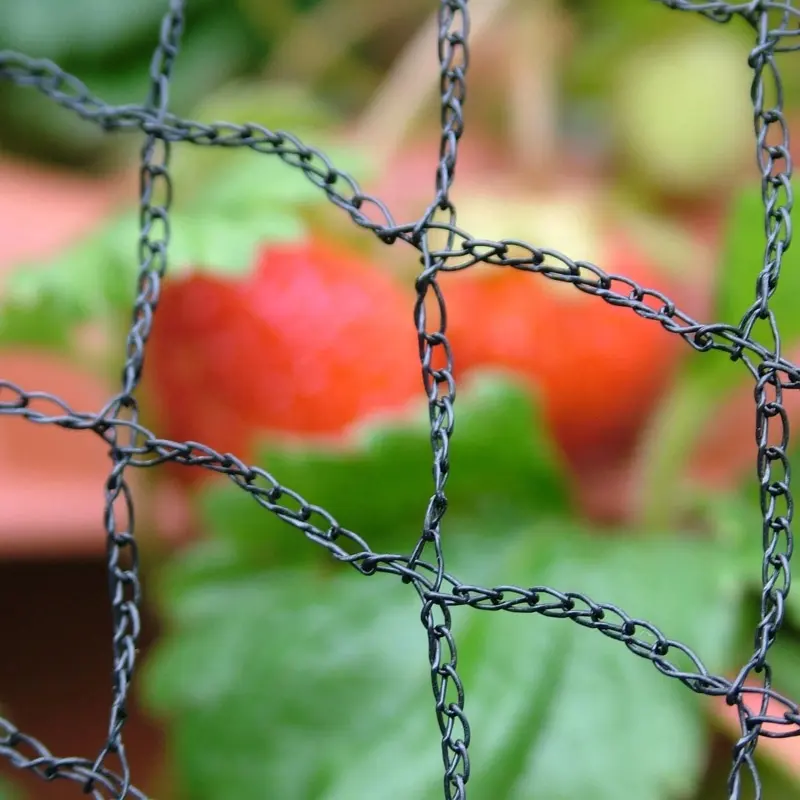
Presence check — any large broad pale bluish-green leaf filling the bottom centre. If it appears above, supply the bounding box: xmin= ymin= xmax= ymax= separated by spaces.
xmin=144 ymin=514 xmax=752 ymax=800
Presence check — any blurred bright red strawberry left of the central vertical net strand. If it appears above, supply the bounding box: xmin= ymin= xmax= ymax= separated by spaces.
xmin=145 ymin=234 xmax=423 ymax=473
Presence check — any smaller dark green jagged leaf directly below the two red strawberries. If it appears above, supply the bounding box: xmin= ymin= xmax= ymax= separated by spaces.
xmin=194 ymin=373 xmax=570 ymax=563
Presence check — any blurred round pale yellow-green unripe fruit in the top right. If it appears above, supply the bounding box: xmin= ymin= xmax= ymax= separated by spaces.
xmin=612 ymin=25 xmax=754 ymax=195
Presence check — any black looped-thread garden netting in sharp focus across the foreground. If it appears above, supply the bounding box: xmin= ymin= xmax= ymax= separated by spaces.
xmin=0 ymin=0 xmax=800 ymax=800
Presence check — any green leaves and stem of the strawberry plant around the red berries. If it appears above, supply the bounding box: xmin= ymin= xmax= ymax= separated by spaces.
xmin=0 ymin=6 xmax=800 ymax=788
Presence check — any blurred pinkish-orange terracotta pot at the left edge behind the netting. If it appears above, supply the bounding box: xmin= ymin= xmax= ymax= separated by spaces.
xmin=0 ymin=156 xmax=191 ymax=557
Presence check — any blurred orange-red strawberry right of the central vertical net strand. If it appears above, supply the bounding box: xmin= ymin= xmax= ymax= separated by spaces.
xmin=442 ymin=231 xmax=685 ymax=467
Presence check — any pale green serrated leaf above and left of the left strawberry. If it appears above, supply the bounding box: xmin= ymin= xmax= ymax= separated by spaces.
xmin=0 ymin=102 xmax=370 ymax=355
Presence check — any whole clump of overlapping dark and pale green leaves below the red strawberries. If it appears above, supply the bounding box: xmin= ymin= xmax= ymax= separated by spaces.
xmin=145 ymin=376 xmax=752 ymax=800
